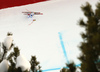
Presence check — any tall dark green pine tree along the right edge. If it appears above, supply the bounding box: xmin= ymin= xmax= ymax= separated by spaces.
xmin=79 ymin=2 xmax=100 ymax=72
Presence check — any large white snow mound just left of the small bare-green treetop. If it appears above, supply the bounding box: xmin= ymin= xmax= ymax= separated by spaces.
xmin=16 ymin=55 xmax=30 ymax=71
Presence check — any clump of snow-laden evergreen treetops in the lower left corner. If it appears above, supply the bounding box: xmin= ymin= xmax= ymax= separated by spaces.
xmin=0 ymin=33 xmax=41 ymax=72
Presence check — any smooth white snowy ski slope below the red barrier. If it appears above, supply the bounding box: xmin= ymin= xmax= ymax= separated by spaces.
xmin=0 ymin=0 xmax=98 ymax=72
